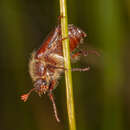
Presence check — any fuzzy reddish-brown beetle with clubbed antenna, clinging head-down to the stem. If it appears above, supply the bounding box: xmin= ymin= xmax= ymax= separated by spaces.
xmin=21 ymin=24 xmax=98 ymax=122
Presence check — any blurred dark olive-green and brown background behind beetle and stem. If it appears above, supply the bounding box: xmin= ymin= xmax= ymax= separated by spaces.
xmin=0 ymin=0 xmax=130 ymax=130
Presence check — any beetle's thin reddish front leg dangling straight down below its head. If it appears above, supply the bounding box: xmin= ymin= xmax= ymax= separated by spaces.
xmin=49 ymin=93 xmax=60 ymax=122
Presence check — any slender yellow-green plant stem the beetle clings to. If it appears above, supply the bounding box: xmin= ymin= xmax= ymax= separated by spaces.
xmin=60 ymin=0 xmax=76 ymax=130
